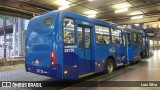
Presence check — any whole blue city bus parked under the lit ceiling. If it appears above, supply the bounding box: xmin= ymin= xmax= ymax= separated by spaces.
xmin=25 ymin=10 xmax=149 ymax=79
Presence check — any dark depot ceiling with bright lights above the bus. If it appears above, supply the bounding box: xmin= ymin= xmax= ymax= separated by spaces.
xmin=0 ymin=0 xmax=160 ymax=24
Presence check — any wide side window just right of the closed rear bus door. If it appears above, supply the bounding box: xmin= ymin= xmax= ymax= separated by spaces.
xmin=95 ymin=25 xmax=110 ymax=44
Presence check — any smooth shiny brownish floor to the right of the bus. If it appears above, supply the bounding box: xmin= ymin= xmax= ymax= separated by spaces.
xmin=63 ymin=50 xmax=160 ymax=90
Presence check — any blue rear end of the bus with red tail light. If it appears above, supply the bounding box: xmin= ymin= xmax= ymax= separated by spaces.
xmin=25 ymin=12 xmax=61 ymax=79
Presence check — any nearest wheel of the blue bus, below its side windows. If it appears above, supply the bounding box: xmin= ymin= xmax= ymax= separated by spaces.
xmin=105 ymin=58 xmax=114 ymax=74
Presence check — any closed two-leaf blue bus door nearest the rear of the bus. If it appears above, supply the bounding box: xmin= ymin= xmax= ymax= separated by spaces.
xmin=77 ymin=25 xmax=92 ymax=75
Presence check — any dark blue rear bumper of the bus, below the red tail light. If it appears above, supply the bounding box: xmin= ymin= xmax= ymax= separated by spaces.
xmin=25 ymin=64 xmax=62 ymax=79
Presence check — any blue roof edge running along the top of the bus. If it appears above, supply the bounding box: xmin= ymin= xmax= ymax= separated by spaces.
xmin=33 ymin=10 xmax=144 ymax=33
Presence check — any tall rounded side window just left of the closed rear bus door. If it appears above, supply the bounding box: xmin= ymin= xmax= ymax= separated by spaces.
xmin=63 ymin=18 xmax=76 ymax=44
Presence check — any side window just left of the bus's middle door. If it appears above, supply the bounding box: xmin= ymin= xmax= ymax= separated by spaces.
xmin=111 ymin=29 xmax=122 ymax=44
